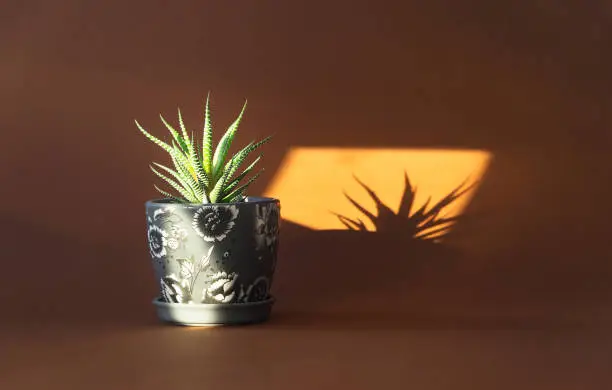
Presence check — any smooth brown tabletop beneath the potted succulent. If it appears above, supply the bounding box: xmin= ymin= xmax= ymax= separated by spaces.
xmin=0 ymin=305 xmax=612 ymax=390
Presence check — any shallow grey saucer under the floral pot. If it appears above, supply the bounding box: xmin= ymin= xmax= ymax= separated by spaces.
xmin=153 ymin=297 xmax=274 ymax=327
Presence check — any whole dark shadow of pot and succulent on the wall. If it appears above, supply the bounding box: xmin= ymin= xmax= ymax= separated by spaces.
xmin=274 ymin=174 xmax=502 ymax=325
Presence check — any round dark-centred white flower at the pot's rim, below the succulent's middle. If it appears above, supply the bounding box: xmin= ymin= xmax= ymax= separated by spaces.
xmin=192 ymin=205 xmax=238 ymax=242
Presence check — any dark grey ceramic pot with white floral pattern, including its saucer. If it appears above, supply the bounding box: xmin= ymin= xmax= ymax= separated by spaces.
xmin=146 ymin=197 xmax=280 ymax=325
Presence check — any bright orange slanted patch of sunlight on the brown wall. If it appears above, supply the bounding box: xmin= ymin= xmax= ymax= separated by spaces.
xmin=265 ymin=147 xmax=491 ymax=230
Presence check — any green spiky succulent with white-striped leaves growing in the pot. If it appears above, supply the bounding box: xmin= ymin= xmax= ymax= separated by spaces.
xmin=135 ymin=94 xmax=271 ymax=203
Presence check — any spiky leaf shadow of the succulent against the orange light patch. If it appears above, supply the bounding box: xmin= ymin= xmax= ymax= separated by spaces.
xmin=333 ymin=172 xmax=476 ymax=242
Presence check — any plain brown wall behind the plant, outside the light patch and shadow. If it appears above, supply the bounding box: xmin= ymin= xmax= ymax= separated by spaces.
xmin=0 ymin=0 xmax=612 ymax=318
